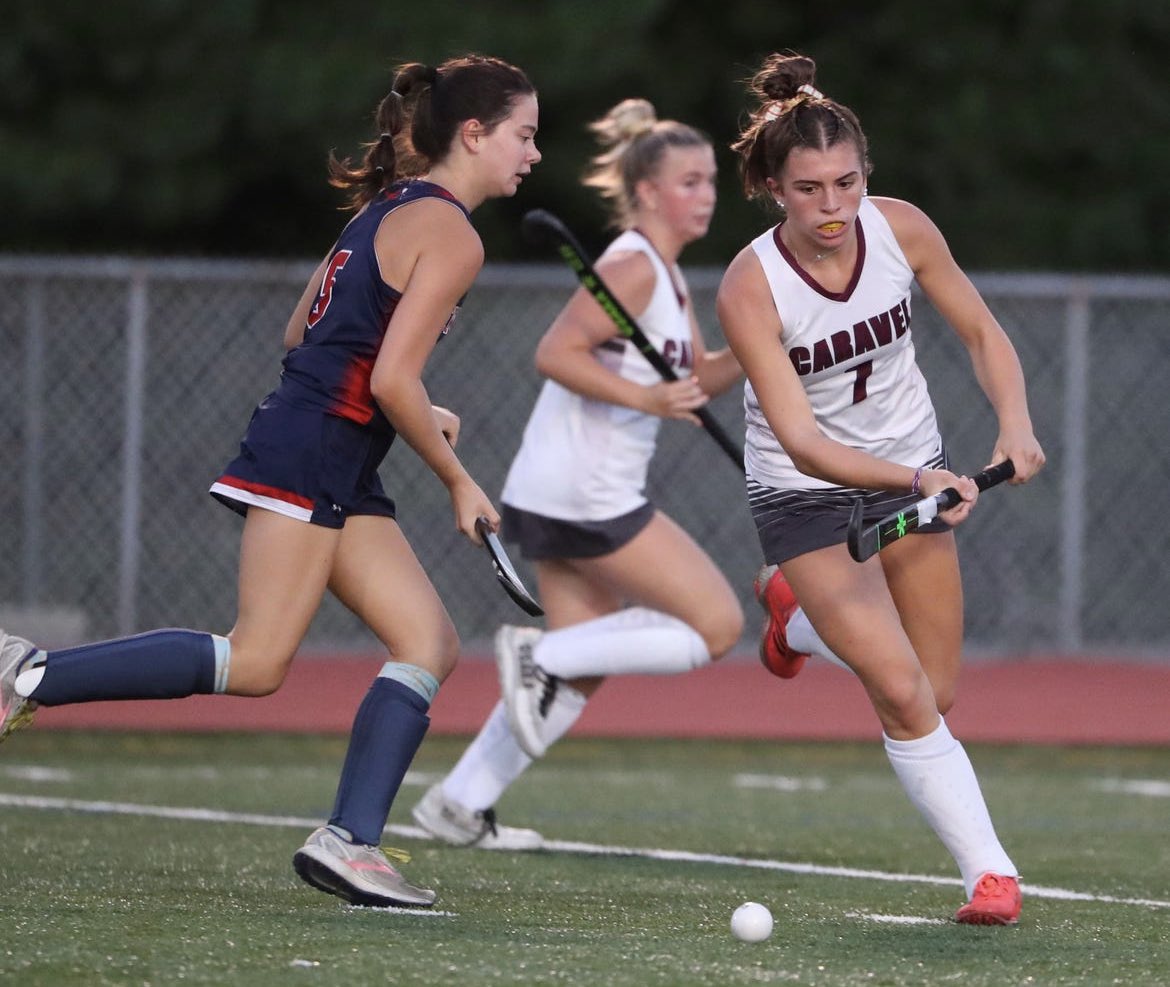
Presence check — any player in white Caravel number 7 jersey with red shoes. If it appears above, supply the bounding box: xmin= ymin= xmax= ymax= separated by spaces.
xmin=717 ymin=54 xmax=1044 ymax=925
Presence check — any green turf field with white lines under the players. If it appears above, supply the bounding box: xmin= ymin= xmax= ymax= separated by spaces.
xmin=0 ymin=730 xmax=1170 ymax=987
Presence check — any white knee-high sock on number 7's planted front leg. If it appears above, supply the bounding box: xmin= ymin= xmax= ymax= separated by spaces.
xmin=883 ymin=717 xmax=1019 ymax=898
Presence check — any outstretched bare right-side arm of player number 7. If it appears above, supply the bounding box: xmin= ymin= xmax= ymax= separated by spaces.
xmin=874 ymin=199 xmax=1045 ymax=483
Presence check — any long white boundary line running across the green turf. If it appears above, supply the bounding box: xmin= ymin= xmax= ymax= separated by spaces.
xmin=0 ymin=792 xmax=1170 ymax=913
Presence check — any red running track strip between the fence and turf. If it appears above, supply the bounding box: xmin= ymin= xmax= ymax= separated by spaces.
xmin=27 ymin=656 xmax=1170 ymax=745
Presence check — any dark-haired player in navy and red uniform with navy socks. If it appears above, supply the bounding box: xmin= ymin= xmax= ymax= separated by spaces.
xmin=0 ymin=55 xmax=541 ymax=906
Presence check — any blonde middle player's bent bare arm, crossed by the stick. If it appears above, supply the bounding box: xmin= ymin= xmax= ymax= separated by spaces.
xmin=536 ymin=251 xmax=707 ymax=425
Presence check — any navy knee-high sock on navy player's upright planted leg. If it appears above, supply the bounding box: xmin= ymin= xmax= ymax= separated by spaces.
xmin=329 ymin=677 xmax=431 ymax=847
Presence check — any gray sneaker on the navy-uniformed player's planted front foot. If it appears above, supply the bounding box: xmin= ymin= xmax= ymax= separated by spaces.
xmin=293 ymin=826 xmax=435 ymax=907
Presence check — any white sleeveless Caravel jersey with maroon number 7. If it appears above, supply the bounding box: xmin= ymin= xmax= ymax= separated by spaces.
xmin=744 ymin=199 xmax=942 ymax=490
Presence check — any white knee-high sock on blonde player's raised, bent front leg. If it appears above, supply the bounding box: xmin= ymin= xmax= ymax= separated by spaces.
xmin=532 ymin=607 xmax=711 ymax=678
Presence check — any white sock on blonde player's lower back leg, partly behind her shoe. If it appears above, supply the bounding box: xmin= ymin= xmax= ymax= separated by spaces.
xmin=442 ymin=683 xmax=586 ymax=810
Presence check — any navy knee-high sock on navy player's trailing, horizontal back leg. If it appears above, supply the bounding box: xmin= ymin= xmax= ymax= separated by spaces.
xmin=29 ymin=628 xmax=215 ymax=706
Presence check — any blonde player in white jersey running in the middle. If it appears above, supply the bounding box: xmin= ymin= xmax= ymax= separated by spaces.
xmin=414 ymin=99 xmax=743 ymax=849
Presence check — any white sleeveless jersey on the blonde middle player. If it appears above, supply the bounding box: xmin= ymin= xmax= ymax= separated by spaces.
xmin=501 ymin=230 xmax=694 ymax=520
